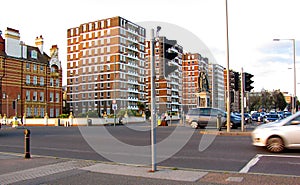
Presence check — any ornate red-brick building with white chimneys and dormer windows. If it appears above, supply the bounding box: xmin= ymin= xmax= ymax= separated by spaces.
xmin=0 ymin=28 xmax=62 ymax=117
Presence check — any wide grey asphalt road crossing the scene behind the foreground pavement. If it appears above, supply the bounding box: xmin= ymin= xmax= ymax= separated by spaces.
xmin=0 ymin=124 xmax=300 ymax=176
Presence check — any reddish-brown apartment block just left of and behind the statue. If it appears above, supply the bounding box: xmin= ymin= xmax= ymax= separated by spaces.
xmin=182 ymin=53 xmax=208 ymax=113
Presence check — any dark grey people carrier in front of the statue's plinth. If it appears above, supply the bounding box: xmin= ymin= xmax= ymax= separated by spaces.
xmin=186 ymin=107 xmax=241 ymax=129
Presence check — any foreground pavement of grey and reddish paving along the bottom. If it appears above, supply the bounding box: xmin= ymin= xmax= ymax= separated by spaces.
xmin=0 ymin=152 xmax=300 ymax=185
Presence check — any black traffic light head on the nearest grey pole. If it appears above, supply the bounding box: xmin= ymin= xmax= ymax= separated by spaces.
xmin=163 ymin=39 xmax=178 ymax=78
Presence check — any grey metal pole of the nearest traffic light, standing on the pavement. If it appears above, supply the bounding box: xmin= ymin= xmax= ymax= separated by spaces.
xmin=150 ymin=29 xmax=156 ymax=172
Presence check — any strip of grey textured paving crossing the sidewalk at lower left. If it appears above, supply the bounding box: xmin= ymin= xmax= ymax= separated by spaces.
xmin=0 ymin=161 xmax=91 ymax=185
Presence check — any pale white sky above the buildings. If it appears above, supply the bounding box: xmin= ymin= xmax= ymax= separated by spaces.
xmin=0 ymin=0 xmax=300 ymax=97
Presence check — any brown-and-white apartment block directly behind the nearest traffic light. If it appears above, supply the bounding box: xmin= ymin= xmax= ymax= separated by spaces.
xmin=146 ymin=36 xmax=183 ymax=115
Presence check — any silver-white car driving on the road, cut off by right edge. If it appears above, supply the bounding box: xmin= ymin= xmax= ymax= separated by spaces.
xmin=252 ymin=111 xmax=300 ymax=152
